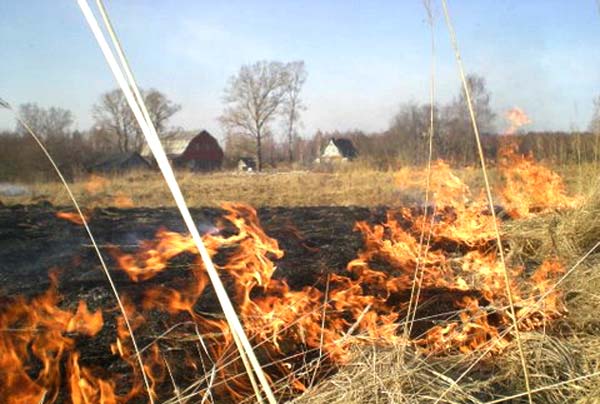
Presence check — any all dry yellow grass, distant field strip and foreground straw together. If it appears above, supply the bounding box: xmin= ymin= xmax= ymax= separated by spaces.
xmin=2 ymin=159 xmax=600 ymax=404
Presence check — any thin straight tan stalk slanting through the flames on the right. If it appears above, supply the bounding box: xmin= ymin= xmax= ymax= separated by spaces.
xmin=438 ymin=0 xmax=533 ymax=404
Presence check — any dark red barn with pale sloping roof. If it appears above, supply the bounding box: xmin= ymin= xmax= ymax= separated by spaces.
xmin=142 ymin=130 xmax=223 ymax=171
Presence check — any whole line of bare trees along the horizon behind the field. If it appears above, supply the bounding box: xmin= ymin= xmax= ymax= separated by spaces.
xmin=0 ymin=57 xmax=600 ymax=181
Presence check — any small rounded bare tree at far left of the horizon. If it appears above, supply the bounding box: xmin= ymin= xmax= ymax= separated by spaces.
xmin=16 ymin=103 xmax=73 ymax=140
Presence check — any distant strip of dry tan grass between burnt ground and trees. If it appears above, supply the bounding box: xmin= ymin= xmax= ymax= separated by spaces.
xmin=0 ymin=164 xmax=596 ymax=208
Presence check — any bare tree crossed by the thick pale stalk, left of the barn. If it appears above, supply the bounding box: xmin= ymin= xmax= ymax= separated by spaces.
xmin=92 ymin=89 xmax=181 ymax=152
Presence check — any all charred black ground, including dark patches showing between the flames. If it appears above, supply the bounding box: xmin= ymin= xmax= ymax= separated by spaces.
xmin=0 ymin=203 xmax=500 ymax=402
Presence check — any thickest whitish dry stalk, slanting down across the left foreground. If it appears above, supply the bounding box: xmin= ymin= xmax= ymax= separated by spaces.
xmin=77 ymin=0 xmax=276 ymax=404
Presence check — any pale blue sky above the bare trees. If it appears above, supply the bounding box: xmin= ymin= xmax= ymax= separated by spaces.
xmin=0 ymin=0 xmax=600 ymax=137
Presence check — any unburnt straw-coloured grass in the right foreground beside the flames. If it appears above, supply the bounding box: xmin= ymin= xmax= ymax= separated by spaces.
xmin=296 ymin=181 xmax=600 ymax=404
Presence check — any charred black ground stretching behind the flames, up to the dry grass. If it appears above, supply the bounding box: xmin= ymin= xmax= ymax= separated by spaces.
xmin=0 ymin=204 xmax=386 ymax=300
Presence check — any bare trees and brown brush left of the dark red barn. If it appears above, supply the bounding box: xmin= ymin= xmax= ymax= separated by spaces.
xmin=0 ymin=89 xmax=181 ymax=181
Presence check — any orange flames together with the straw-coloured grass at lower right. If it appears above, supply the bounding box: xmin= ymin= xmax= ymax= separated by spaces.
xmin=0 ymin=144 xmax=600 ymax=403
